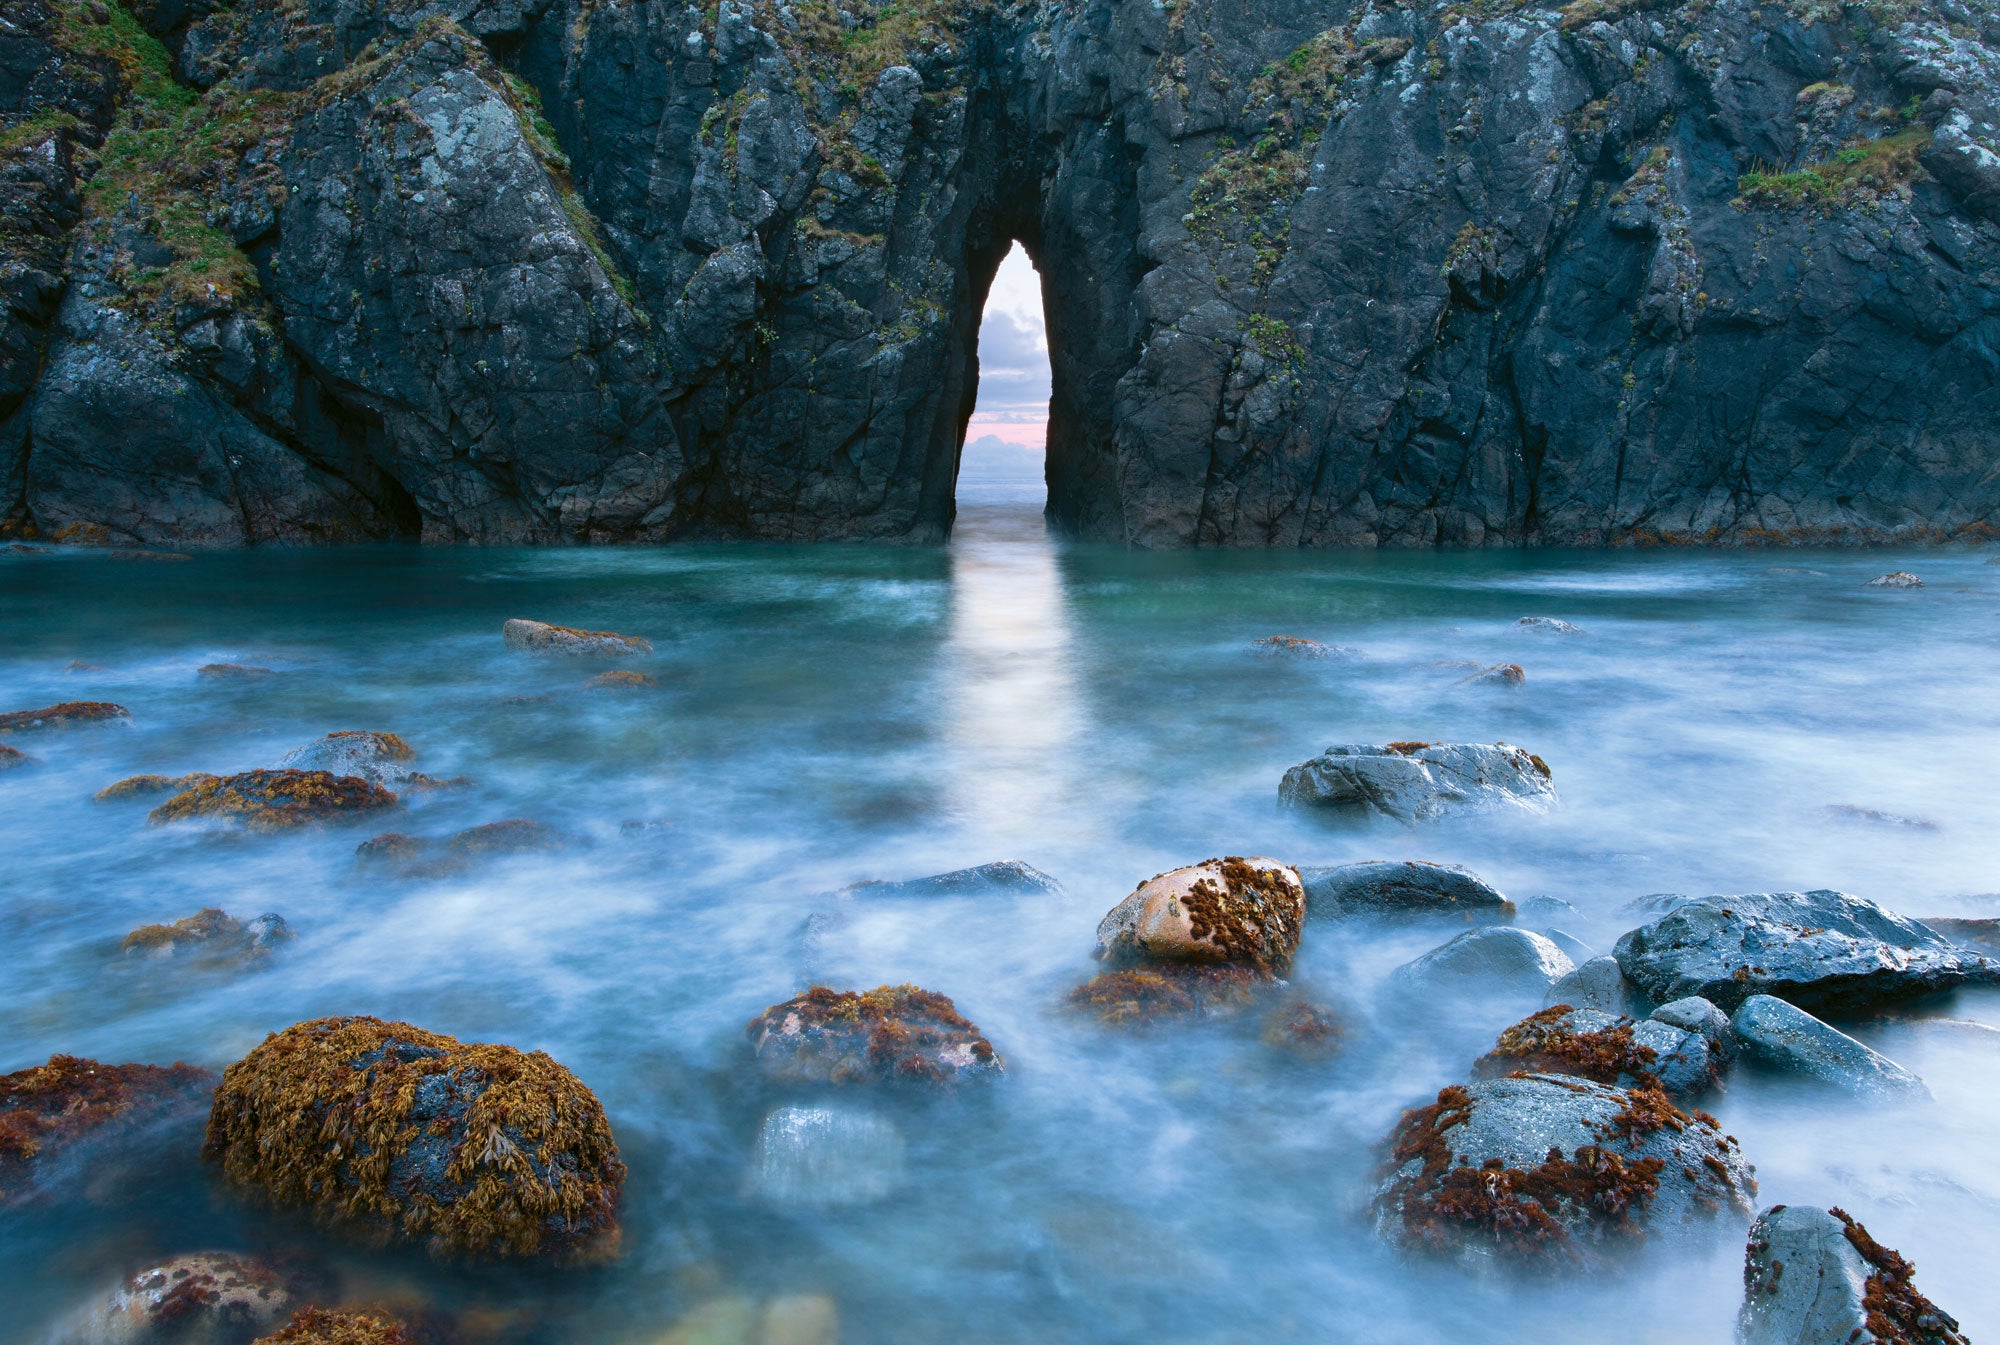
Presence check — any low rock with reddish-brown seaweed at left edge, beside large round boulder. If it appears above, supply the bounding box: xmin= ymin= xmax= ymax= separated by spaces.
xmin=0 ymin=1055 xmax=216 ymax=1207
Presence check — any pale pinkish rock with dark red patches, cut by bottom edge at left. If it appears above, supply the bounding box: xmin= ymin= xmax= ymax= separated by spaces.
xmin=56 ymin=1251 xmax=300 ymax=1345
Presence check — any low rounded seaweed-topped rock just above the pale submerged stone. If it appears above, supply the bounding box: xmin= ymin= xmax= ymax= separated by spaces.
xmin=746 ymin=985 xmax=1000 ymax=1085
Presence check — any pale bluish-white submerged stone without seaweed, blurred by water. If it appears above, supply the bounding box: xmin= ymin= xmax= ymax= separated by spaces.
xmin=750 ymin=1107 xmax=904 ymax=1209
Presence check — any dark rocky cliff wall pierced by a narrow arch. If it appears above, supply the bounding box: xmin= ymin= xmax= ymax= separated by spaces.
xmin=0 ymin=0 xmax=2000 ymax=546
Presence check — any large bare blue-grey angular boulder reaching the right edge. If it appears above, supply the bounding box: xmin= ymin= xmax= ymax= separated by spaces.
xmin=1618 ymin=891 xmax=2000 ymax=1013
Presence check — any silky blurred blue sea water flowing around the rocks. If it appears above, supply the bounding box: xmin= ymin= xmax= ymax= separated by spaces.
xmin=0 ymin=482 xmax=2000 ymax=1345
